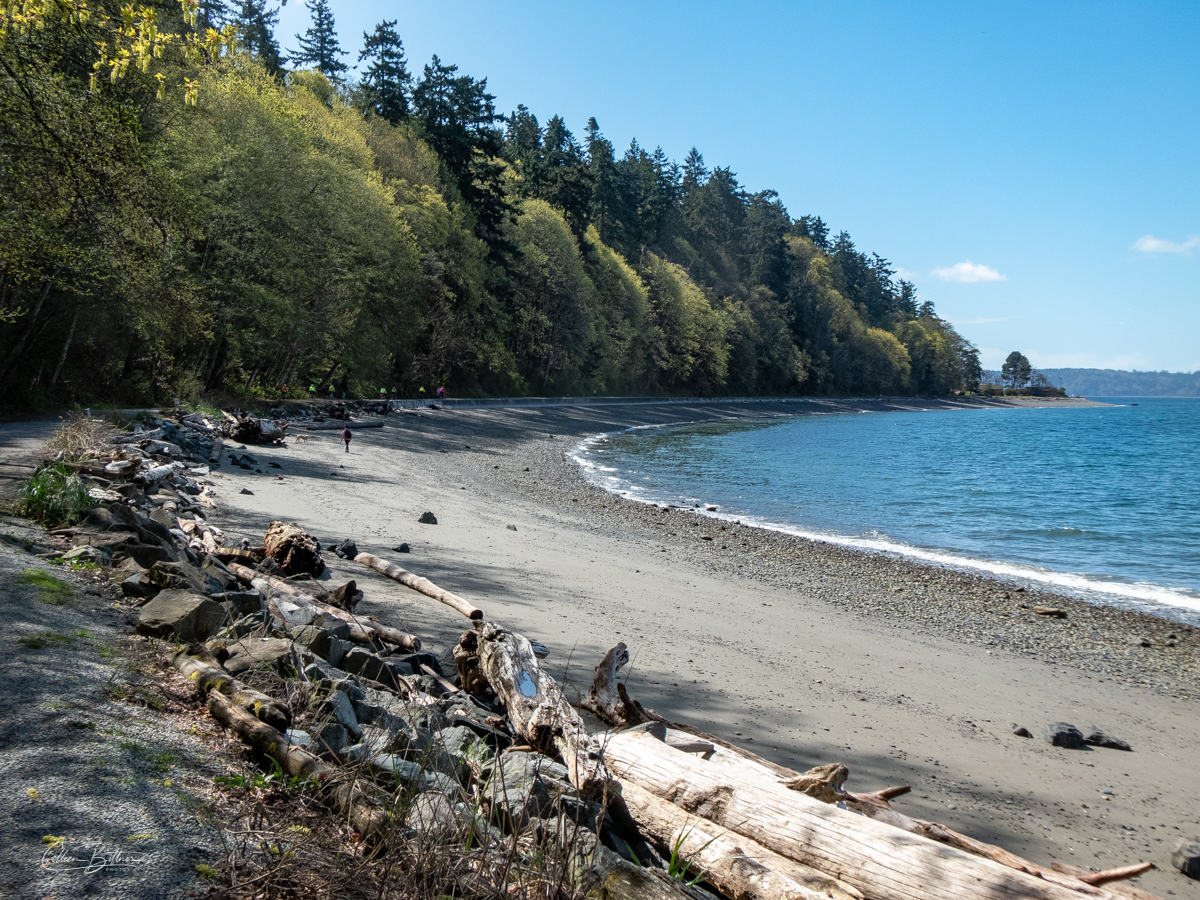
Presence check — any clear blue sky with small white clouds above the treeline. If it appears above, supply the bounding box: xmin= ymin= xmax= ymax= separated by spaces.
xmin=277 ymin=0 xmax=1200 ymax=371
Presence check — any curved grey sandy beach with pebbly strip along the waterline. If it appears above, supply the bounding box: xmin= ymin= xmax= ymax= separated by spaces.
xmin=212 ymin=401 xmax=1200 ymax=900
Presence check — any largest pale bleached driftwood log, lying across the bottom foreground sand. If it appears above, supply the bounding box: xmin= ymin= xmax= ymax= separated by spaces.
xmin=605 ymin=732 xmax=1137 ymax=900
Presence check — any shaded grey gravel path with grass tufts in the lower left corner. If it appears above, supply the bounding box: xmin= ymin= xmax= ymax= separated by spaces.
xmin=0 ymin=520 xmax=226 ymax=900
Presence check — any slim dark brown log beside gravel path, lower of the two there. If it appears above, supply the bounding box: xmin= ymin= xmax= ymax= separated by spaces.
xmin=208 ymin=691 xmax=389 ymax=840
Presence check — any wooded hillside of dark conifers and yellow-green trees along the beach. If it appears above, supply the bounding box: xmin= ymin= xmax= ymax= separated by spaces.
xmin=0 ymin=0 xmax=982 ymax=408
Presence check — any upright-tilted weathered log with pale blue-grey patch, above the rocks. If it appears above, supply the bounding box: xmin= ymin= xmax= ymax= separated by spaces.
xmin=479 ymin=622 xmax=620 ymax=800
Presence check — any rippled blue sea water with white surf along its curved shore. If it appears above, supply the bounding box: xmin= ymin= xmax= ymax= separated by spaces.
xmin=575 ymin=398 xmax=1200 ymax=624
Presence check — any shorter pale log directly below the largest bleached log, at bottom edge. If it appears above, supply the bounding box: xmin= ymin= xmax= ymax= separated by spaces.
xmin=622 ymin=781 xmax=863 ymax=900
